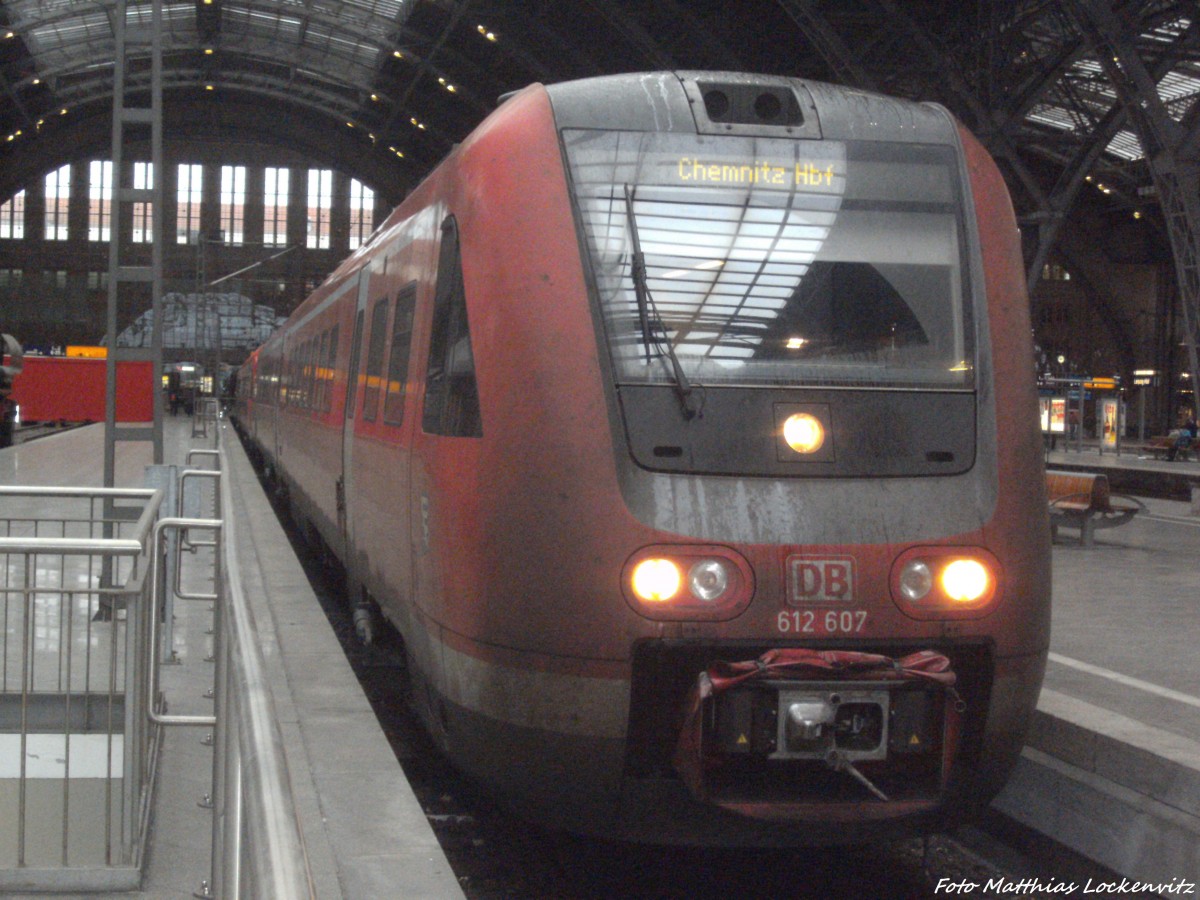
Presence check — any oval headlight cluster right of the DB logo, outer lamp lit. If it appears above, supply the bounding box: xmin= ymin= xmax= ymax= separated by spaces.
xmin=892 ymin=547 xmax=1001 ymax=619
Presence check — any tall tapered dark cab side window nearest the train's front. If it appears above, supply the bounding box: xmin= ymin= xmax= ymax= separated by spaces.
xmin=421 ymin=216 xmax=484 ymax=438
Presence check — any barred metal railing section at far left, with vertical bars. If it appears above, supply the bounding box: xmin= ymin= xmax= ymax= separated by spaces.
xmin=0 ymin=487 xmax=162 ymax=890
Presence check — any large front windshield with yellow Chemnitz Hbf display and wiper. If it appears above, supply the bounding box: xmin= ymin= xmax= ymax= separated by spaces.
xmin=563 ymin=130 xmax=974 ymax=390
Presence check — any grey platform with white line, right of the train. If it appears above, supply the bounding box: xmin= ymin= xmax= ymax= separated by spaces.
xmin=995 ymin=443 xmax=1200 ymax=895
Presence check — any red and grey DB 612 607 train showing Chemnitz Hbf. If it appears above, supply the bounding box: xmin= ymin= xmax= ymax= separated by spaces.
xmin=233 ymin=71 xmax=1050 ymax=846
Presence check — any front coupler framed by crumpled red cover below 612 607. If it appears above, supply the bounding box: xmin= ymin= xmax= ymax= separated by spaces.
xmin=674 ymin=648 xmax=960 ymax=805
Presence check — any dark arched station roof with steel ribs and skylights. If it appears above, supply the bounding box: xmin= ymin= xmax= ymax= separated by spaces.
xmin=0 ymin=0 xmax=1200 ymax=391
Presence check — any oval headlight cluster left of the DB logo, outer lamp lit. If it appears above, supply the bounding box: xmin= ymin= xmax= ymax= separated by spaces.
xmin=622 ymin=545 xmax=754 ymax=620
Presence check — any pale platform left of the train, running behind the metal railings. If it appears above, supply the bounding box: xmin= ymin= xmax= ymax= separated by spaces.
xmin=0 ymin=416 xmax=463 ymax=900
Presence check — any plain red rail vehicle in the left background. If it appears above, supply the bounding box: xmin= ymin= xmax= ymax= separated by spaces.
xmin=12 ymin=356 xmax=155 ymax=422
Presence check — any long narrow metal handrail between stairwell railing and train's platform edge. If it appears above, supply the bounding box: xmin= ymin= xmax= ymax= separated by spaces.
xmin=148 ymin=434 xmax=316 ymax=900
